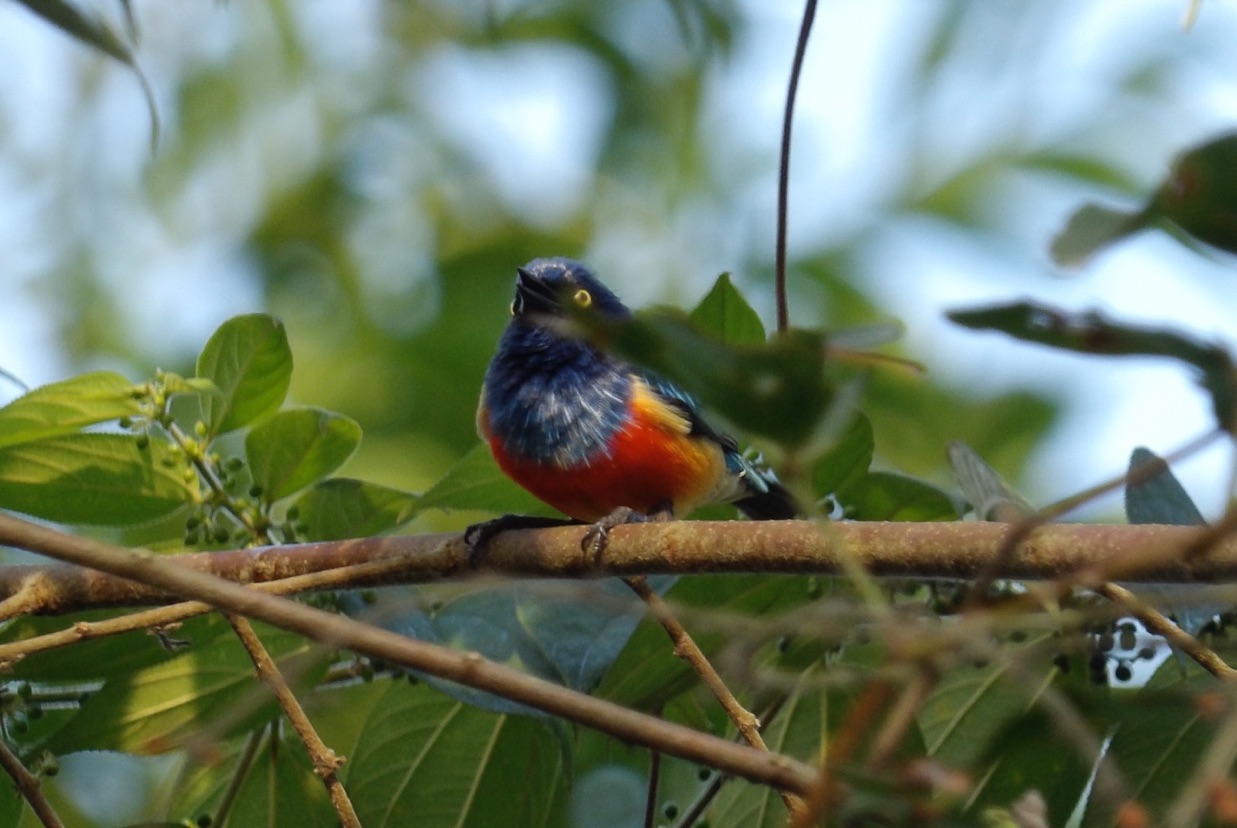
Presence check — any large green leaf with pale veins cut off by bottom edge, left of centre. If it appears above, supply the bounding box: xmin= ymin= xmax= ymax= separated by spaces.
xmin=345 ymin=682 xmax=568 ymax=828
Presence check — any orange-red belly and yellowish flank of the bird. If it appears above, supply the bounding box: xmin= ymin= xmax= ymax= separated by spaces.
xmin=481 ymin=382 xmax=726 ymax=521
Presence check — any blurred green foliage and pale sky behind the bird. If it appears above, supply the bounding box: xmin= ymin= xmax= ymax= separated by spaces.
xmin=7 ymin=0 xmax=1237 ymax=522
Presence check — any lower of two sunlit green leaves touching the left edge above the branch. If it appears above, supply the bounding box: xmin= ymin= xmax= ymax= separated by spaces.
xmin=0 ymin=433 xmax=195 ymax=526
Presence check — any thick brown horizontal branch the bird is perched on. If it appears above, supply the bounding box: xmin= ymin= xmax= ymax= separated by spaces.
xmin=0 ymin=521 xmax=1237 ymax=613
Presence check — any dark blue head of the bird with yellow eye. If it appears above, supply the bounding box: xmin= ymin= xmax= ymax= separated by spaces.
xmin=511 ymin=256 xmax=631 ymax=324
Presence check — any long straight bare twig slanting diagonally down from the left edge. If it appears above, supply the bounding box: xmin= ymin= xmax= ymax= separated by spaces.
xmin=0 ymin=512 xmax=813 ymax=792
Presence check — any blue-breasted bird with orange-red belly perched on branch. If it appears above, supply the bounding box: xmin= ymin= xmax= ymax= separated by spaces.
xmin=467 ymin=256 xmax=799 ymax=541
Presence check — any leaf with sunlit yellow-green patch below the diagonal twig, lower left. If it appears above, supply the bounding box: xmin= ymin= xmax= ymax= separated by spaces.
xmin=47 ymin=625 xmax=325 ymax=754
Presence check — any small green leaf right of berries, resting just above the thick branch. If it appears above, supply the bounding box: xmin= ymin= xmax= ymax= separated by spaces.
xmin=296 ymin=478 xmax=418 ymax=541
